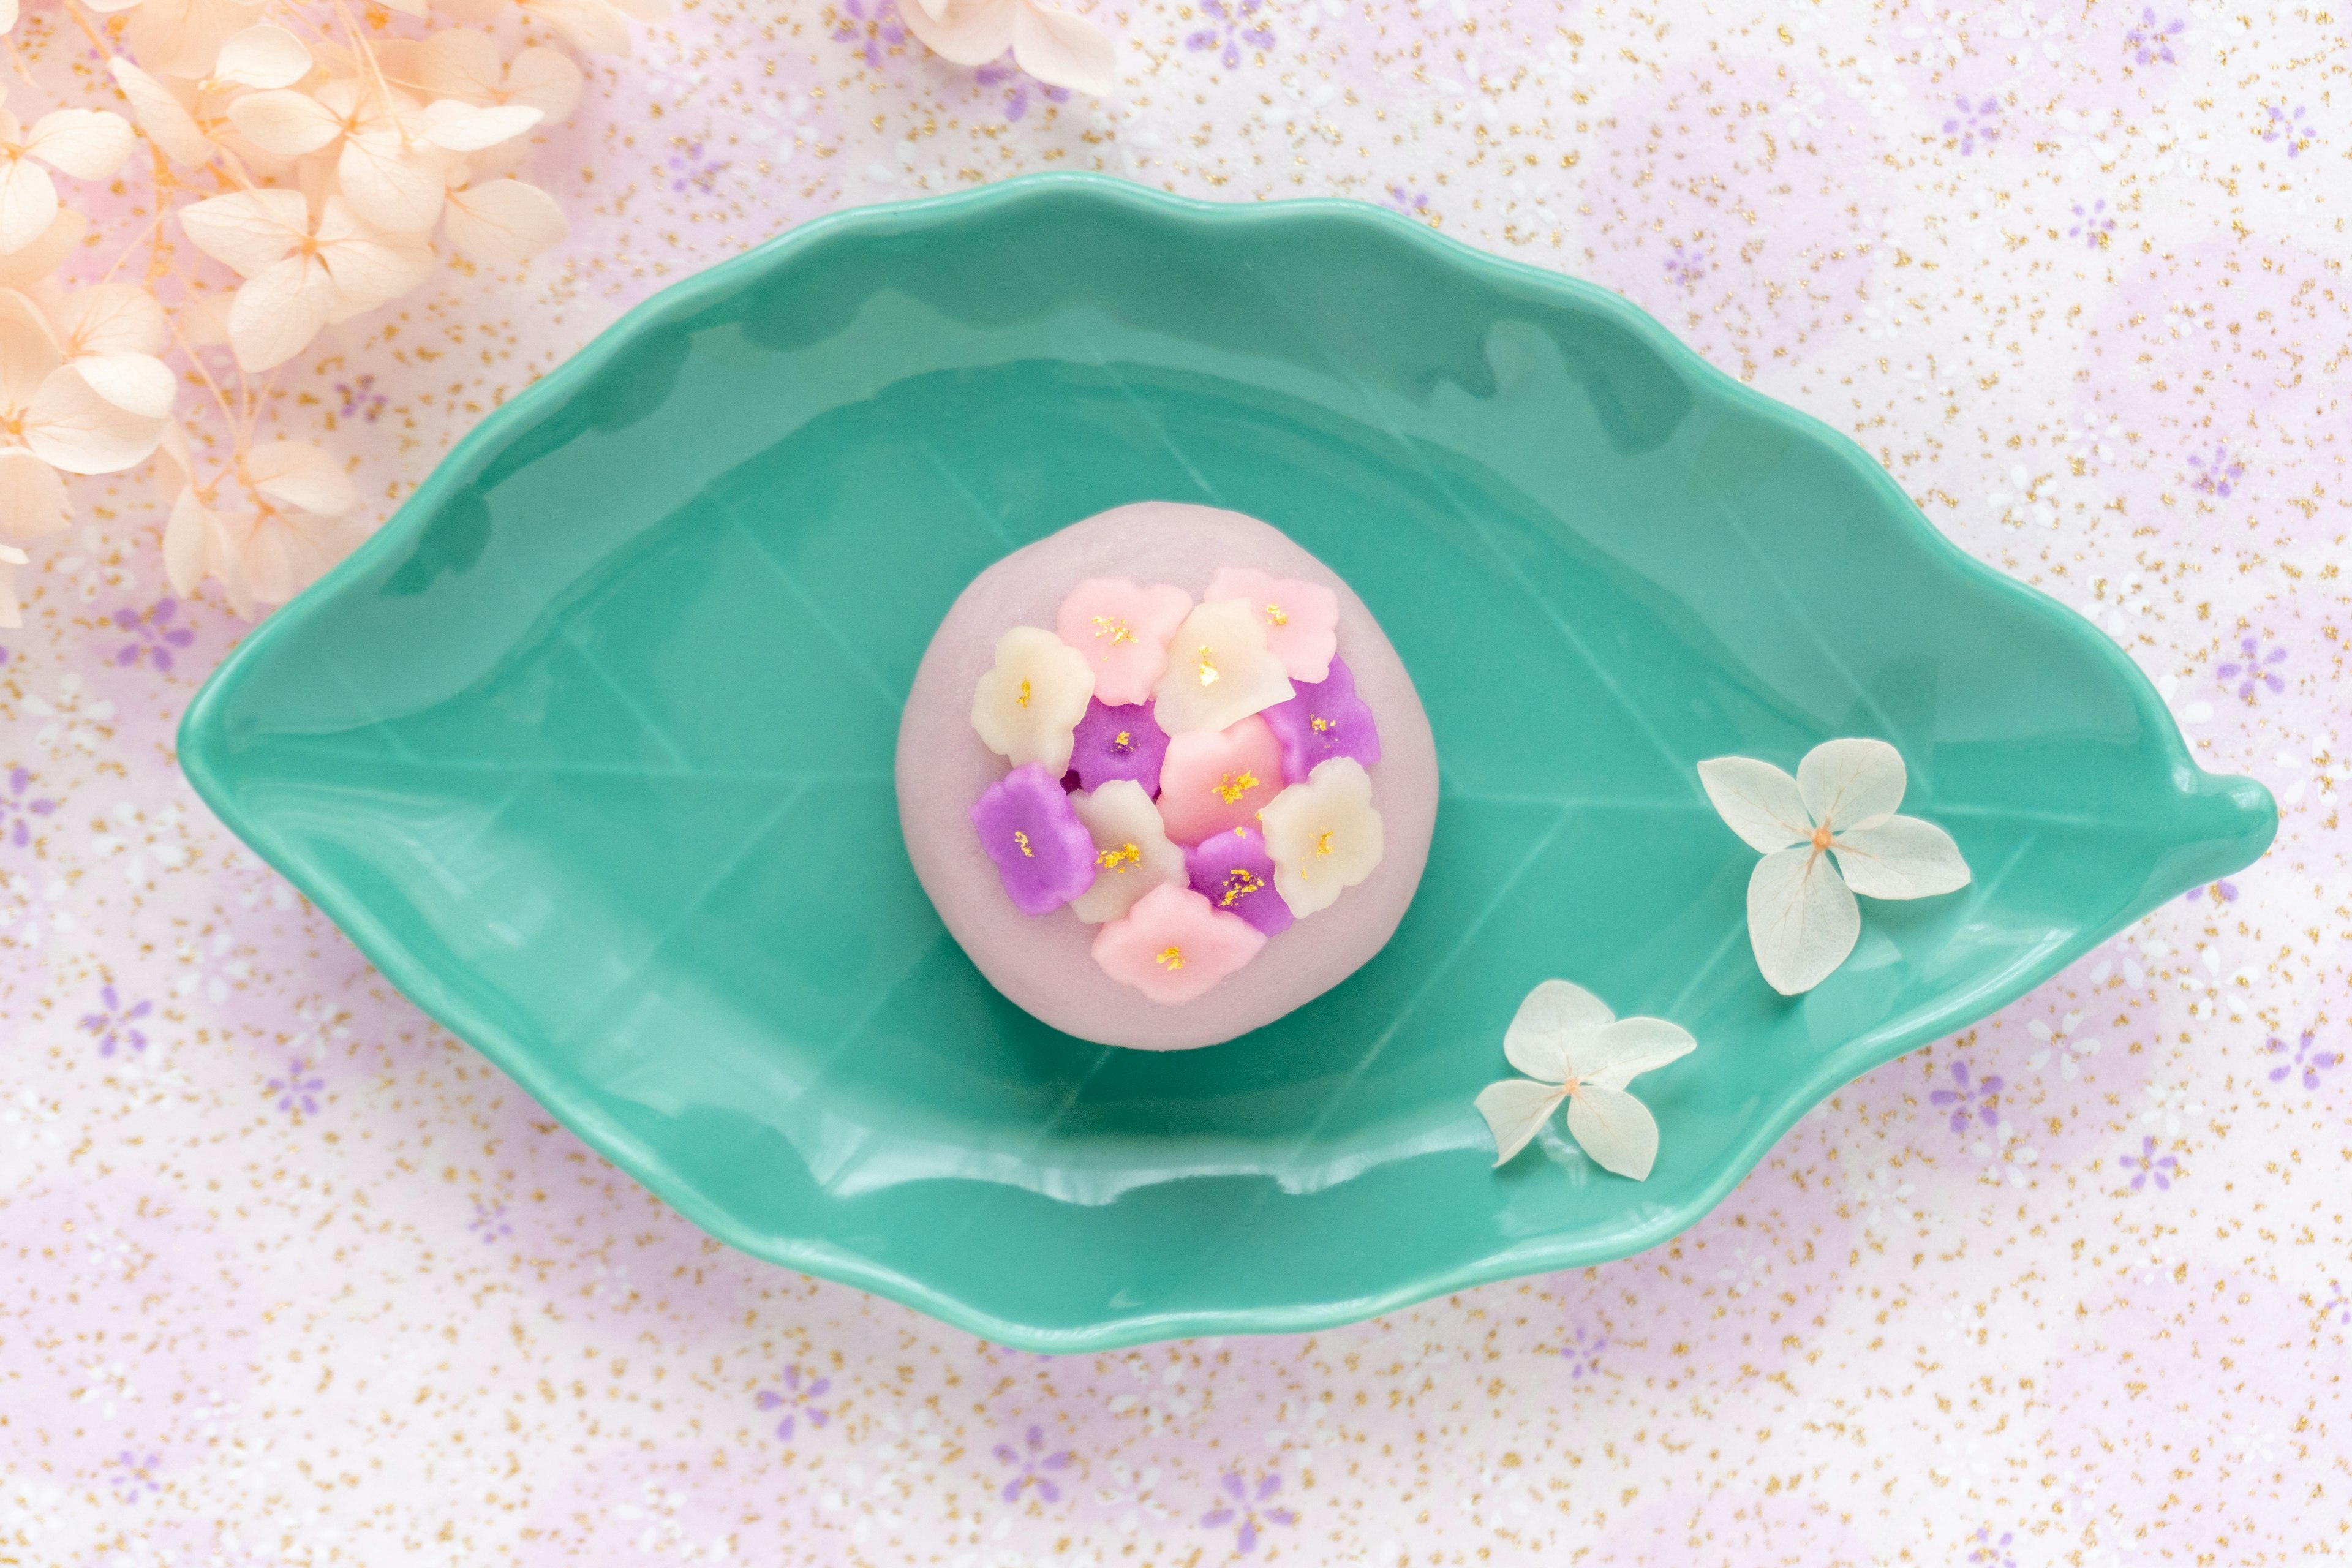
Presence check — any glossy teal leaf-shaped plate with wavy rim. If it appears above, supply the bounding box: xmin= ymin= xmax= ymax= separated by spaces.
xmin=181 ymin=176 xmax=2274 ymax=1349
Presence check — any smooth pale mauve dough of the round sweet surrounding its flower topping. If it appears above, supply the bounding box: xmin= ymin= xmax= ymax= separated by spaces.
xmin=899 ymin=501 xmax=1437 ymax=1051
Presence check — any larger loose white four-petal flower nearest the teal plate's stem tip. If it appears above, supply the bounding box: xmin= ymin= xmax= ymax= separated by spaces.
xmin=1698 ymin=741 xmax=1969 ymax=997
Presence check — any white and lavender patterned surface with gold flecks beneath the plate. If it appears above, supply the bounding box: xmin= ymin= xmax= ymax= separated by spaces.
xmin=0 ymin=0 xmax=2352 ymax=1568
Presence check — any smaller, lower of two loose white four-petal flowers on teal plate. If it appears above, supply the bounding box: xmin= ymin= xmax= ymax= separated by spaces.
xmin=1468 ymin=982 xmax=1698 ymax=1180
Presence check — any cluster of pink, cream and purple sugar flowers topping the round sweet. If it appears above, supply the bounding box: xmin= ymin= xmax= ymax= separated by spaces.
xmin=971 ymin=569 xmax=1385 ymax=1006
